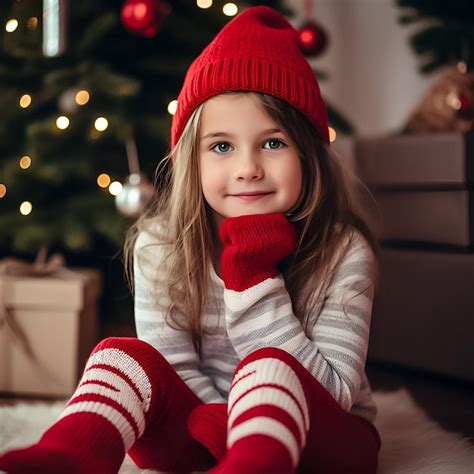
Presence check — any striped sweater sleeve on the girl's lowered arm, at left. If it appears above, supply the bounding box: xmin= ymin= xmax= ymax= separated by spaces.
xmin=133 ymin=231 xmax=225 ymax=403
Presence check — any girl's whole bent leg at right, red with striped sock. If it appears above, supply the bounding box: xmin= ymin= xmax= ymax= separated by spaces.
xmin=211 ymin=348 xmax=380 ymax=474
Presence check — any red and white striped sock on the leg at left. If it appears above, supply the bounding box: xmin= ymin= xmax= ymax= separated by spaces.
xmin=0 ymin=338 xmax=174 ymax=474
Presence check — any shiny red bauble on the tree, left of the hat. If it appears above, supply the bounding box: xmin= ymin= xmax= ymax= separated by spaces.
xmin=121 ymin=0 xmax=169 ymax=38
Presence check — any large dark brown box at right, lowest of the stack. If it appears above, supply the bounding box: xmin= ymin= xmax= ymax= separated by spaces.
xmin=368 ymin=249 xmax=474 ymax=382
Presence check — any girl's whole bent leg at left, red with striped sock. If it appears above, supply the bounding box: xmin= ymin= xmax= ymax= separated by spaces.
xmin=0 ymin=338 xmax=214 ymax=474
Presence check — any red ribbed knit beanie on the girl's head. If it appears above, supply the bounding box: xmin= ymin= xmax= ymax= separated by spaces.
xmin=171 ymin=6 xmax=329 ymax=147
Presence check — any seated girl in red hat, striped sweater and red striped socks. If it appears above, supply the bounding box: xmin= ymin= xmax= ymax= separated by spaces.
xmin=0 ymin=6 xmax=380 ymax=474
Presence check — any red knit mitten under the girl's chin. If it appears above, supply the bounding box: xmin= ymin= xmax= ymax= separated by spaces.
xmin=219 ymin=213 xmax=297 ymax=291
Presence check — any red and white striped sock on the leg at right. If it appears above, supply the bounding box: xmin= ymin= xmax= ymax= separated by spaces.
xmin=210 ymin=348 xmax=310 ymax=474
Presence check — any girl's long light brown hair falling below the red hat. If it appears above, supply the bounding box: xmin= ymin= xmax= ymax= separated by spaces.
xmin=124 ymin=91 xmax=380 ymax=350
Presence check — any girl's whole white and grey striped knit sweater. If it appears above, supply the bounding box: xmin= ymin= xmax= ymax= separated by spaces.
xmin=134 ymin=228 xmax=377 ymax=422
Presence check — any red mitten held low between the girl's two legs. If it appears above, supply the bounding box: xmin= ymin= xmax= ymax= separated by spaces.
xmin=188 ymin=403 xmax=227 ymax=461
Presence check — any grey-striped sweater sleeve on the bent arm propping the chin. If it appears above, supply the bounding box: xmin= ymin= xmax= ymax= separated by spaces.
xmin=224 ymin=232 xmax=374 ymax=411
